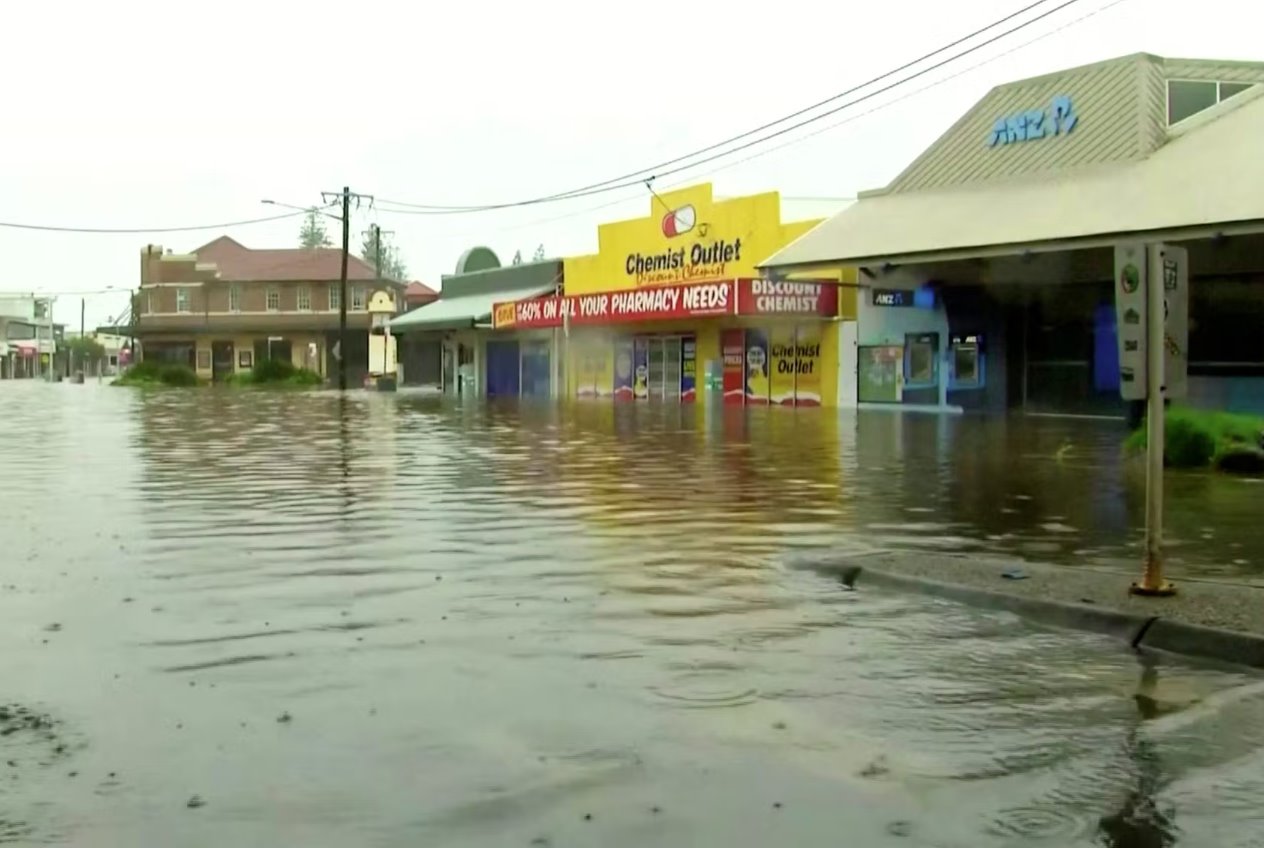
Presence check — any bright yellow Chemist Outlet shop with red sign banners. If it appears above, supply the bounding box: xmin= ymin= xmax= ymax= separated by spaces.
xmin=492 ymin=183 xmax=856 ymax=406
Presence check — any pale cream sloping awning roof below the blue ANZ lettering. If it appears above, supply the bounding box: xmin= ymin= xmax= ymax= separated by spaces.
xmin=761 ymin=86 xmax=1264 ymax=272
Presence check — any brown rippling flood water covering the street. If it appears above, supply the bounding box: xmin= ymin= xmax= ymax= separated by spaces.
xmin=0 ymin=382 xmax=1264 ymax=848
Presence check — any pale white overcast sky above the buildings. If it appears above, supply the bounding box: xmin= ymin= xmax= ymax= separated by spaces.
xmin=0 ymin=0 xmax=1264 ymax=324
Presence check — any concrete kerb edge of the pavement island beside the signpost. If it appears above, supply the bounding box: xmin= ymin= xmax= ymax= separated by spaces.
xmin=796 ymin=561 xmax=1264 ymax=669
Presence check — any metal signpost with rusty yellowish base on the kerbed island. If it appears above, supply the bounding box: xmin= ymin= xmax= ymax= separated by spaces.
xmin=1129 ymin=244 xmax=1177 ymax=598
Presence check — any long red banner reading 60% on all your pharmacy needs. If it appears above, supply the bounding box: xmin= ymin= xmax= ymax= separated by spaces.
xmin=492 ymin=281 xmax=737 ymax=329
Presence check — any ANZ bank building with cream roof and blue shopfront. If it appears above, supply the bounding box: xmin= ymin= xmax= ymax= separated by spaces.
xmin=762 ymin=54 xmax=1264 ymax=416
